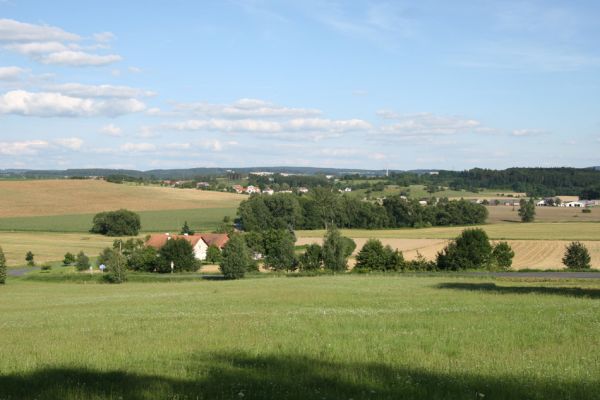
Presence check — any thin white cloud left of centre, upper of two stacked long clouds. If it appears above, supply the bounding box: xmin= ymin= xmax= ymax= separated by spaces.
xmin=175 ymin=99 xmax=321 ymax=119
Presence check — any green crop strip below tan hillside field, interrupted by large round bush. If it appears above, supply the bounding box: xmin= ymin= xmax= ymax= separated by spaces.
xmin=0 ymin=208 xmax=236 ymax=232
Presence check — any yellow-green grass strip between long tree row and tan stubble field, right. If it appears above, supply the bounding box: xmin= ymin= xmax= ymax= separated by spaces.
xmin=296 ymin=222 xmax=600 ymax=240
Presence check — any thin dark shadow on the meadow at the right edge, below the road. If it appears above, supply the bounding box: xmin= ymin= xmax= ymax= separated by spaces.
xmin=436 ymin=282 xmax=600 ymax=299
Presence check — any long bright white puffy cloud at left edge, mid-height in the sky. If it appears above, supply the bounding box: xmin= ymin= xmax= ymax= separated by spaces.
xmin=0 ymin=90 xmax=145 ymax=117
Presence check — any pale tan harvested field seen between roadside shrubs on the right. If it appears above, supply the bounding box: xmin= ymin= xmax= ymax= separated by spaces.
xmin=297 ymin=237 xmax=600 ymax=270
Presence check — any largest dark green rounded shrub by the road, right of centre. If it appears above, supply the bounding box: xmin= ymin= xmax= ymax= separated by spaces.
xmin=437 ymin=228 xmax=492 ymax=271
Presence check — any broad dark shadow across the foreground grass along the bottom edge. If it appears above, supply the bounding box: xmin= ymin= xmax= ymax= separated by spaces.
xmin=0 ymin=353 xmax=600 ymax=400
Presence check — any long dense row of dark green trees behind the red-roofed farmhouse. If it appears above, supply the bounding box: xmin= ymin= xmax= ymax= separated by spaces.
xmin=238 ymin=188 xmax=488 ymax=231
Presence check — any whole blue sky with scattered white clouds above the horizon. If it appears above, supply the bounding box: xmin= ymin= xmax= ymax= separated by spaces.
xmin=0 ymin=0 xmax=600 ymax=169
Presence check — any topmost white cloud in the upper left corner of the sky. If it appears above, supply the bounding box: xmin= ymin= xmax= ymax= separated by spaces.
xmin=0 ymin=19 xmax=80 ymax=42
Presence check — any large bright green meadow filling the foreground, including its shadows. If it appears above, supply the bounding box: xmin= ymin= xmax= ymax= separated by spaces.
xmin=0 ymin=275 xmax=600 ymax=399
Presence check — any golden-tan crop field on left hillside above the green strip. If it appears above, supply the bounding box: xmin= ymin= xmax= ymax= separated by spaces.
xmin=0 ymin=180 xmax=246 ymax=218
